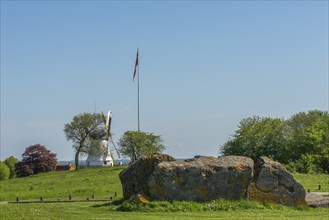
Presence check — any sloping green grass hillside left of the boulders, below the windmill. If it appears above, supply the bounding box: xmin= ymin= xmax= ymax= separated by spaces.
xmin=0 ymin=167 xmax=123 ymax=201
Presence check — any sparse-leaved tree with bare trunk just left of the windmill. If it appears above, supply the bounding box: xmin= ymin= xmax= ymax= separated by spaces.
xmin=64 ymin=113 xmax=102 ymax=170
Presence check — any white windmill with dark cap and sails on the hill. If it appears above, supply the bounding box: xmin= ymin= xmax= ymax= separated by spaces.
xmin=87 ymin=111 xmax=120 ymax=166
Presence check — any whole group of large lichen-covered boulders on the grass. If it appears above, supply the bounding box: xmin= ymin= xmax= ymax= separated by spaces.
xmin=120 ymin=154 xmax=307 ymax=206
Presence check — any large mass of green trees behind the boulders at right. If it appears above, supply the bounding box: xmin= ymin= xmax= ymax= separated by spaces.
xmin=220 ymin=110 xmax=329 ymax=173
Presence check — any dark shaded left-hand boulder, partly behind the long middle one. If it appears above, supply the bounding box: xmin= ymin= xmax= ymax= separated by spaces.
xmin=119 ymin=154 xmax=175 ymax=199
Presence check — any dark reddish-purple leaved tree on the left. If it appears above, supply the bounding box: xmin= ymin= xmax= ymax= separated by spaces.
xmin=15 ymin=144 xmax=57 ymax=177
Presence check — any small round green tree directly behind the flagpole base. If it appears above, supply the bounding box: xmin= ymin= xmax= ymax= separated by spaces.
xmin=119 ymin=131 xmax=165 ymax=162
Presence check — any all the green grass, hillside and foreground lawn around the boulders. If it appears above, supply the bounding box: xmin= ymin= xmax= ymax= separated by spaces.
xmin=0 ymin=167 xmax=329 ymax=220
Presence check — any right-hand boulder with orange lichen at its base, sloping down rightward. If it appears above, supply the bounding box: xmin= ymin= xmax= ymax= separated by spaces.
xmin=247 ymin=157 xmax=307 ymax=206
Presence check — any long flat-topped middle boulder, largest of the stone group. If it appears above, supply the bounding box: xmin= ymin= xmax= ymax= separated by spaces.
xmin=147 ymin=156 xmax=254 ymax=201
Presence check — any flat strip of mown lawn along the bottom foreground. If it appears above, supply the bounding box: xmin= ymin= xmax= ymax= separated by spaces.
xmin=0 ymin=202 xmax=329 ymax=220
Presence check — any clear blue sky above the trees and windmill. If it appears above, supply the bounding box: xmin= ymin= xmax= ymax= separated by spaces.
xmin=0 ymin=0 xmax=329 ymax=160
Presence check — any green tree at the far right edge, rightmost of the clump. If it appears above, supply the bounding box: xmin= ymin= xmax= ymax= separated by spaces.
xmin=284 ymin=110 xmax=329 ymax=173
